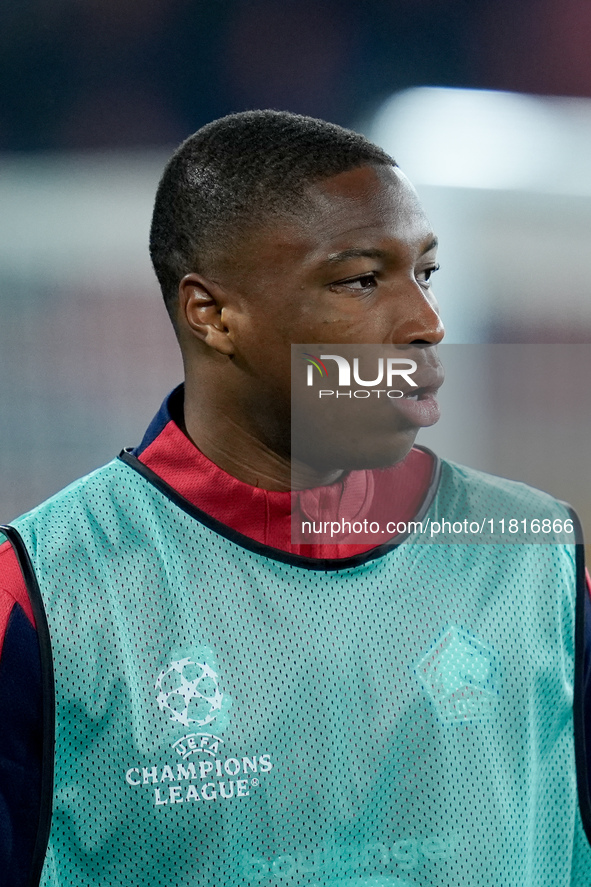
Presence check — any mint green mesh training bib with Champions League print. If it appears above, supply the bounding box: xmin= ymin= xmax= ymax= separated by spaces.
xmin=4 ymin=458 xmax=591 ymax=887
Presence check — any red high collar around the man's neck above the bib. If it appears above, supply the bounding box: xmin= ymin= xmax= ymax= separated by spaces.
xmin=135 ymin=389 xmax=434 ymax=558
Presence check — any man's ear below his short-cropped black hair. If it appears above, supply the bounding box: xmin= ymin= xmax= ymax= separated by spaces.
xmin=178 ymin=273 xmax=234 ymax=355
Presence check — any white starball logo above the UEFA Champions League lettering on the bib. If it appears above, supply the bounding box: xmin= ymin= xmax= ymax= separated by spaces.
xmin=155 ymin=656 xmax=224 ymax=727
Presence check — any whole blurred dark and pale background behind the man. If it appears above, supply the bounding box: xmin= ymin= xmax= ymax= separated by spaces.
xmin=0 ymin=0 xmax=591 ymax=535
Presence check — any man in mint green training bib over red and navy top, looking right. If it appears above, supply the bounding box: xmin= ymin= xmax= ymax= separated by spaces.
xmin=0 ymin=112 xmax=591 ymax=887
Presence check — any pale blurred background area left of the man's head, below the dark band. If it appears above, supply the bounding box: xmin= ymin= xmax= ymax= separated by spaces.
xmin=0 ymin=151 xmax=182 ymax=522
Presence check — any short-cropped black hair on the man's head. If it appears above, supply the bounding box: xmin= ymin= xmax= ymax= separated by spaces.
xmin=150 ymin=111 xmax=396 ymax=317
